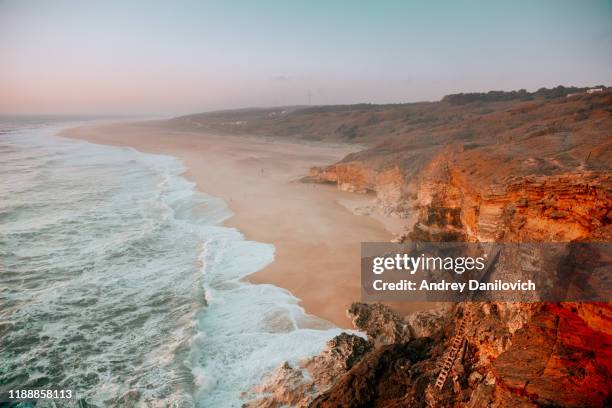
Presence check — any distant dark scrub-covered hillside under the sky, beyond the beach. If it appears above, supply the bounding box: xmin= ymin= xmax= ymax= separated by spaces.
xmin=168 ymin=87 xmax=609 ymax=149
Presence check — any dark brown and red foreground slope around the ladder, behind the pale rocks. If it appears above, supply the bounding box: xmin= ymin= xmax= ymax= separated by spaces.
xmin=311 ymin=303 xmax=612 ymax=407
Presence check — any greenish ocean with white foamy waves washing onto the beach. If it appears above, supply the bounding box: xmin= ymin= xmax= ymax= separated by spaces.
xmin=0 ymin=118 xmax=340 ymax=408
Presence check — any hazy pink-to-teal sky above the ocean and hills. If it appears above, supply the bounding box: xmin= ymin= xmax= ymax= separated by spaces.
xmin=0 ymin=0 xmax=612 ymax=115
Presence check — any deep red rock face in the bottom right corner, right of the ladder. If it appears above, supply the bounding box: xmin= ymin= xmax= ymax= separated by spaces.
xmin=492 ymin=303 xmax=612 ymax=407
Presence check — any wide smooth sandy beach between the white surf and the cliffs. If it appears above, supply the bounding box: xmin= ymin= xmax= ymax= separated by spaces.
xmin=64 ymin=124 xmax=393 ymax=328
